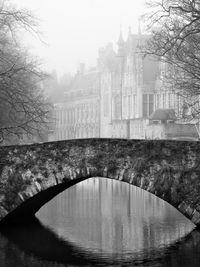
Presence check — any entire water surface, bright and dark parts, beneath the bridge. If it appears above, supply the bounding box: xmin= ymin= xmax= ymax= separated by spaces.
xmin=0 ymin=178 xmax=200 ymax=267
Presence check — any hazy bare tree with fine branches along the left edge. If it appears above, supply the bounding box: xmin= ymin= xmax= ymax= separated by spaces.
xmin=0 ymin=1 xmax=49 ymax=142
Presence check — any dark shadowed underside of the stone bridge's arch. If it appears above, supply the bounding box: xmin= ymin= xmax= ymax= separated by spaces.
xmin=0 ymin=176 xmax=200 ymax=230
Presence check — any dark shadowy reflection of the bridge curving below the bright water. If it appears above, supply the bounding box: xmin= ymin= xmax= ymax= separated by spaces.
xmin=0 ymin=219 xmax=200 ymax=266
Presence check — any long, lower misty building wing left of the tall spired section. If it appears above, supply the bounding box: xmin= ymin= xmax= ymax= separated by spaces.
xmin=49 ymin=66 xmax=100 ymax=140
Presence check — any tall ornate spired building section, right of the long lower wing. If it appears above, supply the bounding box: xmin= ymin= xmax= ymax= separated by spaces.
xmin=98 ymin=29 xmax=198 ymax=140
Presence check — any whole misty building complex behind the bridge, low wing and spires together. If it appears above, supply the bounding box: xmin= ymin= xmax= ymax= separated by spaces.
xmin=50 ymin=29 xmax=198 ymax=140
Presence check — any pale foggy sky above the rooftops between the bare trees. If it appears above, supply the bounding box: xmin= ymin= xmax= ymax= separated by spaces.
xmin=11 ymin=0 xmax=145 ymax=75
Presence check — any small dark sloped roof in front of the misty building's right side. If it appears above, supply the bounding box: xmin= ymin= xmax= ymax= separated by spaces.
xmin=149 ymin=109 xmax=176 ymax=121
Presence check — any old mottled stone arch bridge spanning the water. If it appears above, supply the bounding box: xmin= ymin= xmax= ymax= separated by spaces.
xmin=0 ymin=139 xmax=200 ymax=226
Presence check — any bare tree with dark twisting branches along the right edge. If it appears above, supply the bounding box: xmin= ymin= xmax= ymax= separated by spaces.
xmin=145 ymin=0 xmax=200 ymax=119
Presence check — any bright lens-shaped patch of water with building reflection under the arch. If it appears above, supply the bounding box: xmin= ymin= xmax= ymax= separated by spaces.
xmin=38 ymin=178 xmax=194 ymax=257
